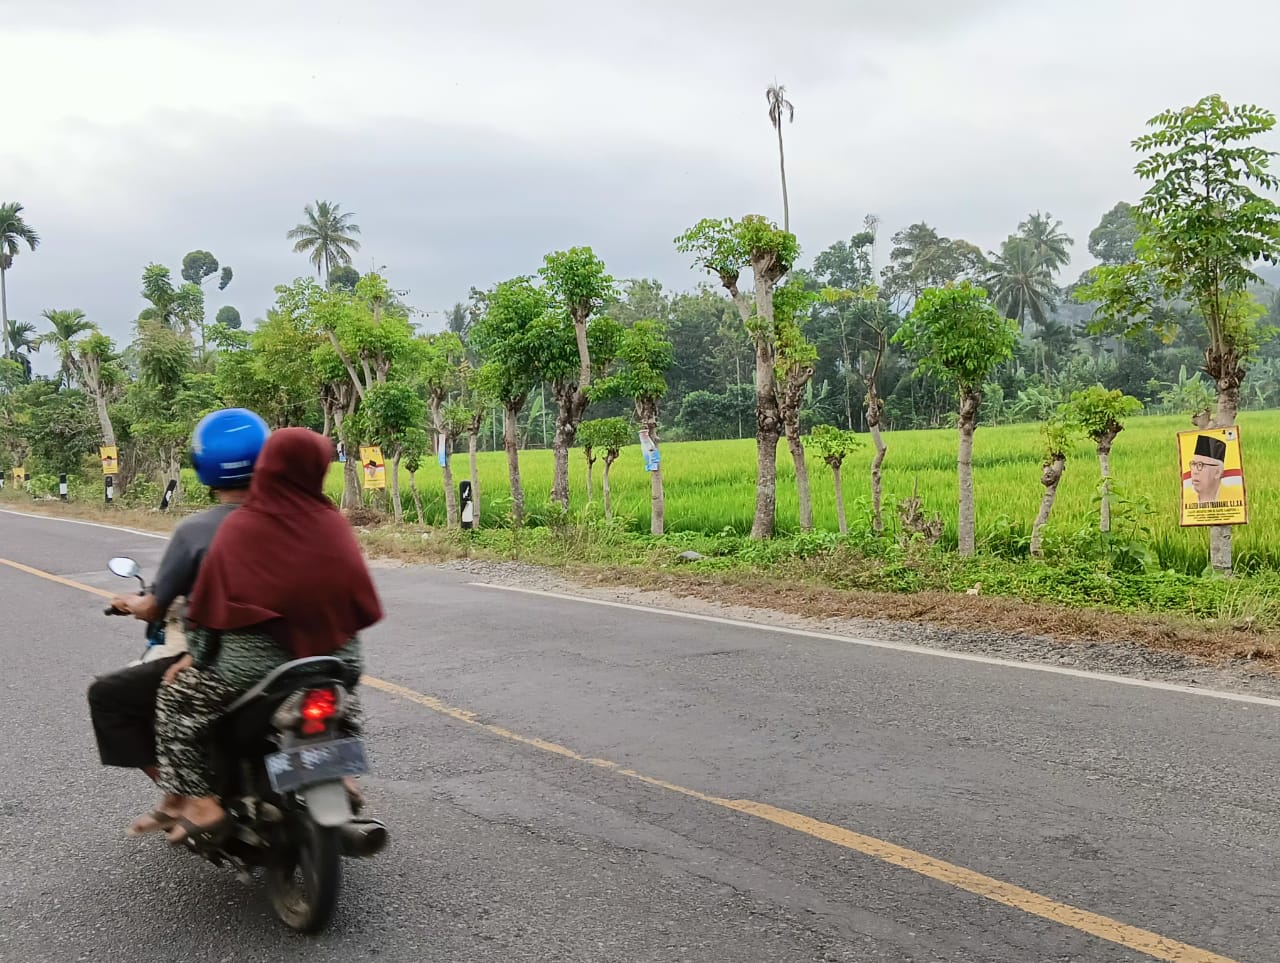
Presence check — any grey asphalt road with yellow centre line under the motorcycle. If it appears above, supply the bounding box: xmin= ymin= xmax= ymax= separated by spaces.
xmin=0 ymin=514 xmax=1280 ymax=963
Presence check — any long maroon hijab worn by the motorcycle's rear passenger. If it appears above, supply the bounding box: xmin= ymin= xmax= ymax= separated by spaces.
xmin=187 ymin=428 xmax=383 ymax=658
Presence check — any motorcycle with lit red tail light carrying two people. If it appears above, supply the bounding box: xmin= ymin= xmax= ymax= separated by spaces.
xmin=104 ymin=557 xmax=387 ymax=934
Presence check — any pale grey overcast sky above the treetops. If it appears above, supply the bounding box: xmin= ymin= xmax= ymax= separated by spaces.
xmin=0 ymin=0 xmax=1280 ymax=370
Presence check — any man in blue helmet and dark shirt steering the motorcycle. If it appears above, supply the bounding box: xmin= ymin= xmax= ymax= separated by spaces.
xmin=88 ymin=409 xmax=270 ymax=835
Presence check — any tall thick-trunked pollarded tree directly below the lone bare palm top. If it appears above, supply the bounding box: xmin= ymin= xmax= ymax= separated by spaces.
xmin=676 ymin=214 xmax=800 ymax=539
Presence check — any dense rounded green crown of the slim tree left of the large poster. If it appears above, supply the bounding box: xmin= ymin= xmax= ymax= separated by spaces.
xmin=893 ymin=282 xmax=1018 ymax=394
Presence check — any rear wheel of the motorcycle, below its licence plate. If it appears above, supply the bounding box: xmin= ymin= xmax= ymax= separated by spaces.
xmin=266 ymin=813 xmax=342 ymax=934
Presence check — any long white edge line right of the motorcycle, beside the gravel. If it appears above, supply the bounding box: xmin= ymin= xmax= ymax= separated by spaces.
xmin=467 ymin=581 xmax=1280 ymax=708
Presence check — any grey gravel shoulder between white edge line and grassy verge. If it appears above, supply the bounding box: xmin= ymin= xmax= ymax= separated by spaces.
xmin=412 ymin=558 xmax=1280 ymax=698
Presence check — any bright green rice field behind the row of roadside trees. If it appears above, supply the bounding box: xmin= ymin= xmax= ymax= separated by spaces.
xmin=328 ymin=411 xmax=1280 ymax=572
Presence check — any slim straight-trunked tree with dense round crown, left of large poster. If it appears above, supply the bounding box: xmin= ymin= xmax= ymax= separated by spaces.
xmin=893 ymin=282 xmax=1018 ymax=556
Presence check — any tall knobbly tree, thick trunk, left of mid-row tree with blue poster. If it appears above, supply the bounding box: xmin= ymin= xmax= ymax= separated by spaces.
xmin=538 ymin=247 xmax=617 ymax=508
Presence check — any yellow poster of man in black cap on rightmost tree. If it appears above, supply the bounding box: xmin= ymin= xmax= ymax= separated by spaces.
xmin=1178 ymin=425 xmax=1249 ymax=528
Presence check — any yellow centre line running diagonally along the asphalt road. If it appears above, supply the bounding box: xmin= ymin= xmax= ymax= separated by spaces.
xmin=0 ymin=558 xmax=1236 ymax=963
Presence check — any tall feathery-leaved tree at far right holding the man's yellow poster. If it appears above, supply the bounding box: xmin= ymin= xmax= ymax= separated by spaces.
xmin=1078 ymin=95 xmax=1280 ymax=572
